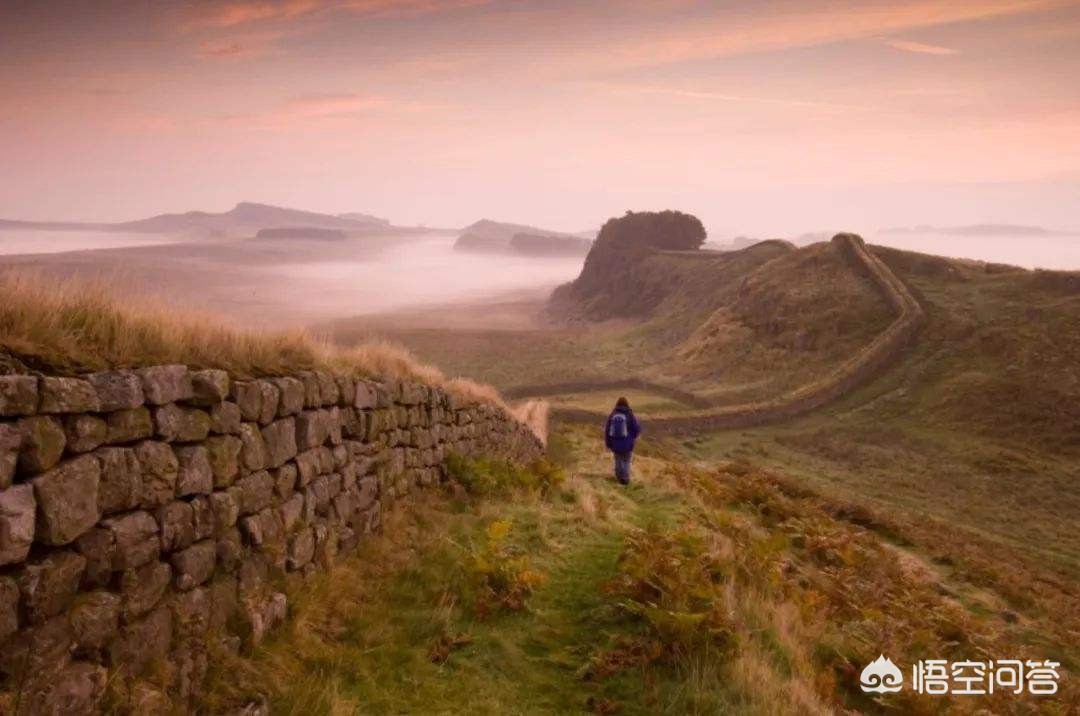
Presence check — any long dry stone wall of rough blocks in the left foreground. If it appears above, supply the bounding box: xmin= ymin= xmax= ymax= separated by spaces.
xmin=0 ymin=365 xmax=542 ymax=714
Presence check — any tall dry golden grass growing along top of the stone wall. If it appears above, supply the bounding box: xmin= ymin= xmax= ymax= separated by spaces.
xmin=0 ymin=273 xmax=546 ymax=436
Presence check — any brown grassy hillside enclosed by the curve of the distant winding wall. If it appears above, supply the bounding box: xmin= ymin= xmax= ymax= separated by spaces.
xmin=354 ymin=243 xmax=892 ymax=403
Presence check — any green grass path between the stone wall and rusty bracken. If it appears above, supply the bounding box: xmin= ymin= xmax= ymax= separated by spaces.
xmin=208 ymin=440 xmax=699 ymax=714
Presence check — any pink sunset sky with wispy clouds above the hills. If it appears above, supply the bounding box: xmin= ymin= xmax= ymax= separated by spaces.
xmin=0 ymin=0 xmax=1080 ymax=234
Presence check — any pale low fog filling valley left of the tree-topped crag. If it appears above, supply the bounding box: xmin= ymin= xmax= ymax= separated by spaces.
xmin=0 ymin=231 xmax=583 ymax=328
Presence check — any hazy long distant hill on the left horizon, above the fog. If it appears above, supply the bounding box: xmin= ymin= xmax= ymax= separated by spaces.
xmin=0 ymin=202 xmax=416 ymax=238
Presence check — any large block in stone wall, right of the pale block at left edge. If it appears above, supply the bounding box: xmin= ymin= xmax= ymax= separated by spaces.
xmin=32 ymin=455 xmax=102 ymax=545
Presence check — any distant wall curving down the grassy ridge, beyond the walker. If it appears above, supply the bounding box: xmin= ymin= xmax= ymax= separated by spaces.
xmin=535 ymin=233 xmax=926 ymax=433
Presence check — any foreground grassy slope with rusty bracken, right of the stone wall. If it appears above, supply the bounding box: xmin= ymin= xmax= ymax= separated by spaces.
xmin=205 ymin=431 xmax=1080 ymax=714
